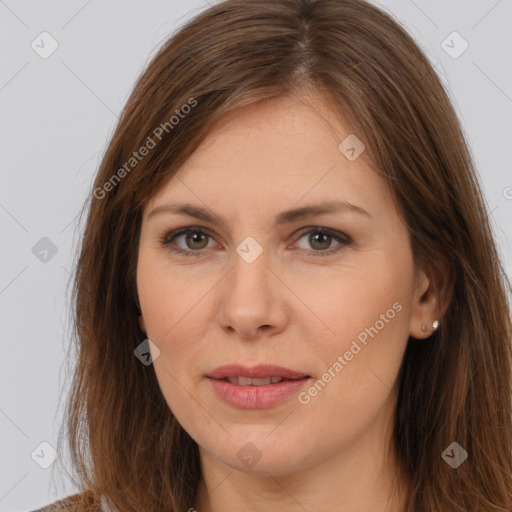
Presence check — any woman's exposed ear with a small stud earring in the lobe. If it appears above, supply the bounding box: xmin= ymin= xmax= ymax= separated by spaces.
xmin=409 ymin=265 xmax=454 ymax=340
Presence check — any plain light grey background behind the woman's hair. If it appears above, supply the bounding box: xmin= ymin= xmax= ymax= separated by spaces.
xmin=0 ymin=0 xmax=512 ymax=512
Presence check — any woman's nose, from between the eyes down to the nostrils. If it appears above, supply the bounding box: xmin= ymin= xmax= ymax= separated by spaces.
xmin=217 ymin=249 xmax=289 ymax=339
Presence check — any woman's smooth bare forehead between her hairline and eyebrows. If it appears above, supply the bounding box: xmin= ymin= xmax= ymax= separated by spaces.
xmin=144 ymin=96 xmax=389 ymax=224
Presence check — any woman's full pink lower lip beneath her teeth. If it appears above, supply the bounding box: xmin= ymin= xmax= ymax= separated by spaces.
xmin=207 ymin=377 xmax=309 ymax=409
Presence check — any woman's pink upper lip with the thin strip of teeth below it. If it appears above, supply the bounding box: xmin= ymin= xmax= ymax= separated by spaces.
xmin=207 ymin=364 xmax=309 ymax=386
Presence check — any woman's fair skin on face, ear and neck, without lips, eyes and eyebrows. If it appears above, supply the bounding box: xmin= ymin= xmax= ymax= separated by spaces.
xmin=137 ymin=96 xmax=437 ymax=512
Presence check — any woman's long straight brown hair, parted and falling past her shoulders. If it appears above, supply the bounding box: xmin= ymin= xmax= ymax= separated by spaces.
xmin=53 ymin=0 xmax=512 ymax=512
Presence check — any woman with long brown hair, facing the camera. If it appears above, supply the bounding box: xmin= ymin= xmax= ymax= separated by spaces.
xmin=37 ymin=0 xmax=512 ymax=512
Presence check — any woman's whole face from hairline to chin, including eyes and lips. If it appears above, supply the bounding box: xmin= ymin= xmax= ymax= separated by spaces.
xmin=137 ymin=97 xmax=432 ymax=475
